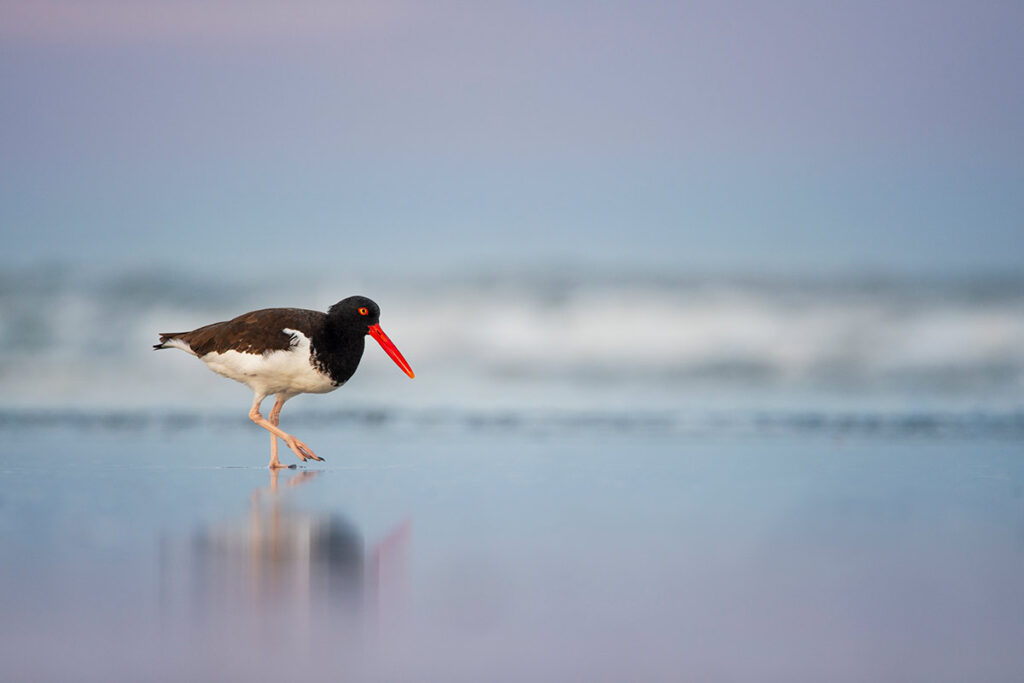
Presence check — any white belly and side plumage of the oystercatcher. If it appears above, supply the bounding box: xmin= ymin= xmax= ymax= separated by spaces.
xmin=200 ymin=328 xmax=338 ymax=396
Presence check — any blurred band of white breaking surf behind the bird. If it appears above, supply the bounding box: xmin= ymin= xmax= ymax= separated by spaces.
xmin=0 ymin=271 xmax=1024 ymax=408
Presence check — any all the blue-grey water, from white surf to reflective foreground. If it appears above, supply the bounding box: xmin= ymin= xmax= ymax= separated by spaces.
xmin=0 ymin=268 xmax=1024 ymax=682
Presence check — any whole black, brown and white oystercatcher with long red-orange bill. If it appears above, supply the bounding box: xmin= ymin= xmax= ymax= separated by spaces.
xmin=153 ymin=296 xmax=416 ymax=469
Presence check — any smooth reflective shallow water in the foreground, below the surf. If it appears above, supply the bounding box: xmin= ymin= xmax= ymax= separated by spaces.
xmin=0 ymin=423 xmax=1024 ymax=681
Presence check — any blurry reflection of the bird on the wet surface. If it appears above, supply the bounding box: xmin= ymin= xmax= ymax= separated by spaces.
xmin=161 ymin=470 xmax=412 ymax=659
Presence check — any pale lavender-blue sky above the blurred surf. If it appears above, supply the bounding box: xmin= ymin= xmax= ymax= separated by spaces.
xmin=0 ymin=0 xmax=1024 ymax=271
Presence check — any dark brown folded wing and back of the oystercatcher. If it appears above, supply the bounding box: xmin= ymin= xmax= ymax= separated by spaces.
xmin=160 ymin=308 xmax=327 ymax=356
